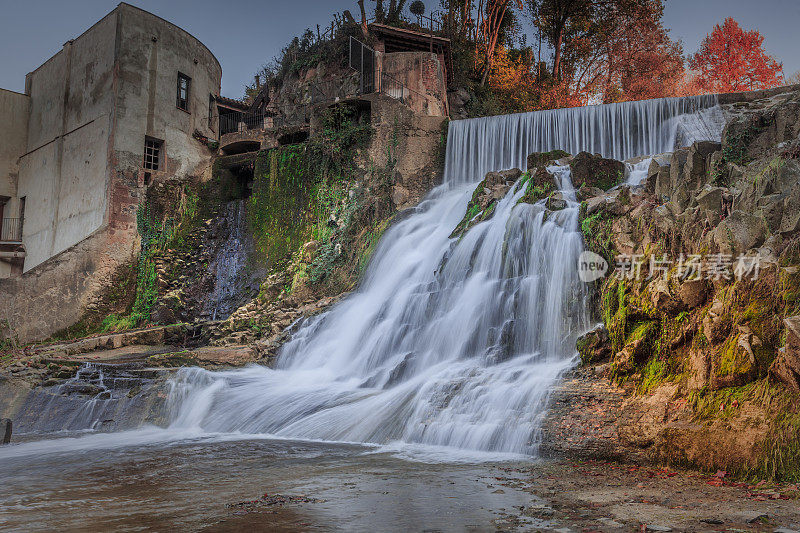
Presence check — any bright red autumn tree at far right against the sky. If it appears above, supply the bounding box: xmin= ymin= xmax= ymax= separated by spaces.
xmin=689 ymin=17 xmax=783 ymax=93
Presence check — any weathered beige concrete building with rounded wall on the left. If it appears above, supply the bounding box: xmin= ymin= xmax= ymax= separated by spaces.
xmin=0 ymin=3 xmax=222 ymax=340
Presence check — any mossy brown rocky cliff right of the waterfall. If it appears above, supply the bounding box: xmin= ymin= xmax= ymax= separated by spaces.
xmin=564 ymin=92 xmax=800 ymax=478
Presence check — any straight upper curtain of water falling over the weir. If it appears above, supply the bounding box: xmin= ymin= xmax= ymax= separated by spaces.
xmin=445 ymin=95 xmax=725 ymax=183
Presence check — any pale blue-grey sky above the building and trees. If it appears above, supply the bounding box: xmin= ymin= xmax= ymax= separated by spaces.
xmin=0 ymin=0 xmax=800 ymax=98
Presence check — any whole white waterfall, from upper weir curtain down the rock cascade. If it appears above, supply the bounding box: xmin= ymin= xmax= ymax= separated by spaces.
xmin=4 ymin=93 xmax=718 ymax=454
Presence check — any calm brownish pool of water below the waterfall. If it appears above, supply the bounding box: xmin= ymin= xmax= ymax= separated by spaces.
xmin=0 ymin=430 xmax=533 ymax=531
